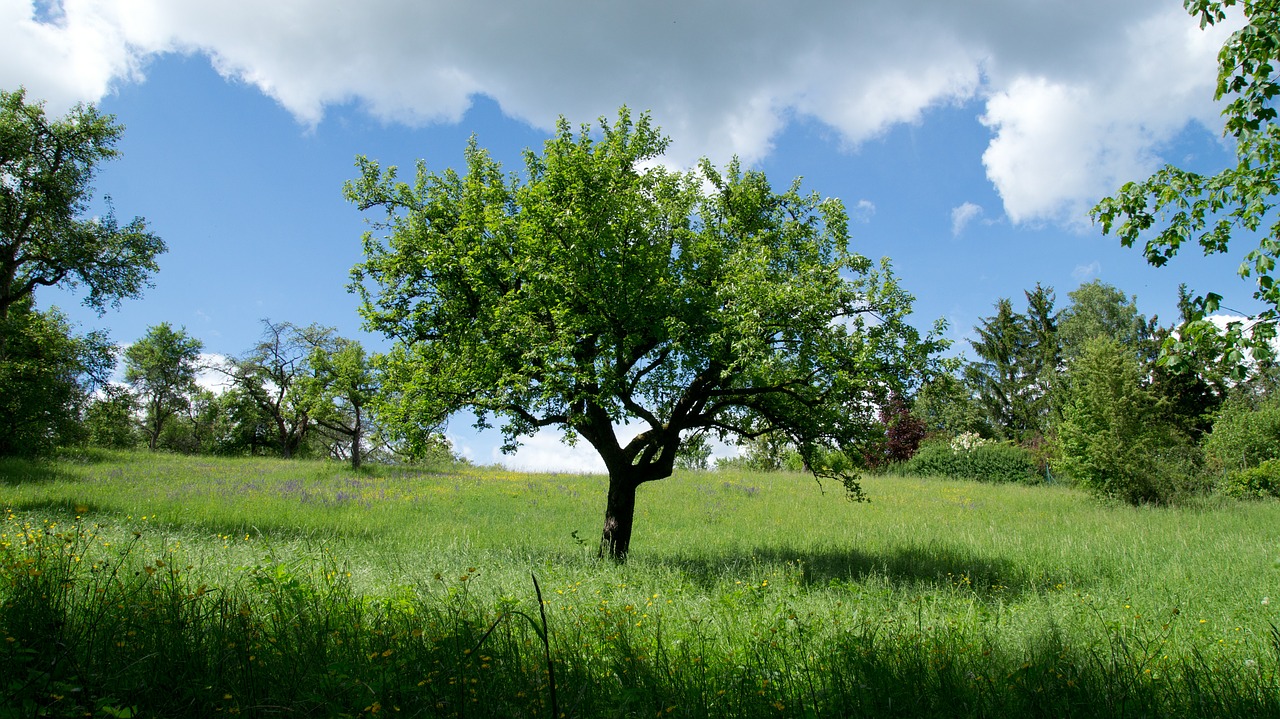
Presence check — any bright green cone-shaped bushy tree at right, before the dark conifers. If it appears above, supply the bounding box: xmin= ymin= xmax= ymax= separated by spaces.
xmin=1055 ymin=336 xmax=1196 ymax=504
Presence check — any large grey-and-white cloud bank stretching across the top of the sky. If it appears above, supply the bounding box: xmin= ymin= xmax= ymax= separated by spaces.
xmin=0 ymin=0 xmax=1225 ymax=223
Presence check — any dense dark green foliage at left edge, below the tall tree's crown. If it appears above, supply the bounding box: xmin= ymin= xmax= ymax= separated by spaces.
xmin=0 ymin=297 xmax=115 ymax=457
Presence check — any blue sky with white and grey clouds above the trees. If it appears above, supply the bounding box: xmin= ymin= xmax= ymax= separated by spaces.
xmin=0 ymin=0 xmax=1257 ymax=471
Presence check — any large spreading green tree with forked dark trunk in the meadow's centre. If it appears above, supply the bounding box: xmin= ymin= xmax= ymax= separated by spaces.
xmin=346 ymin=107 xmax=943 ymax=560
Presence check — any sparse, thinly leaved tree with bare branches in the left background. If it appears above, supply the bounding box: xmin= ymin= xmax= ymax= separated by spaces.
xmin=230 ymin=320 xmax=333 ymax=459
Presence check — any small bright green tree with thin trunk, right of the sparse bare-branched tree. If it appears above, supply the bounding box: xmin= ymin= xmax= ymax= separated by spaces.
xmin=305 ymin=338 xmax=380 ymax=470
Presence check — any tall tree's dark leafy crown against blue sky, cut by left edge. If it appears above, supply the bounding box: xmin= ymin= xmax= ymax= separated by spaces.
xmin=0 ymin=88 xmax=165 ymax=319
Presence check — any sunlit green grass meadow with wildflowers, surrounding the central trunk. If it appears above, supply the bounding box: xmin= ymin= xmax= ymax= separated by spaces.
xmin=0 ymin=453 xmax=1280 ymax=718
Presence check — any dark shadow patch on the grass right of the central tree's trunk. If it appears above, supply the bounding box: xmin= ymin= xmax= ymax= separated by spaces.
xmin=641 ymin=544 xmax=1079 ymax=599
